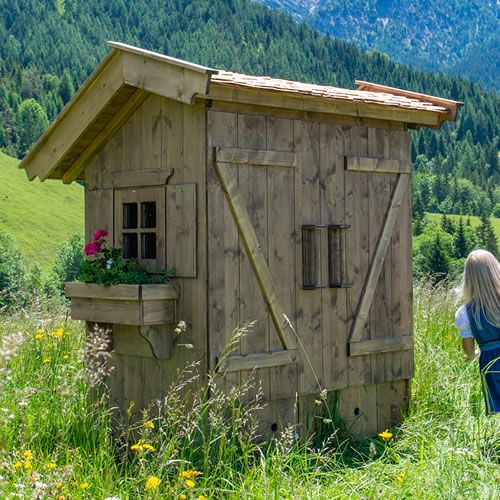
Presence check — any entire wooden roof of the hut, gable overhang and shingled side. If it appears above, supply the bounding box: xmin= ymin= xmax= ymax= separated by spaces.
xmin=20 ymin=42 xmax=462 ymax=183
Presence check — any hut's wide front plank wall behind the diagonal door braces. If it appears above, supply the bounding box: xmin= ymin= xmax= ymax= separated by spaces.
xmin=207 ymin=108 xmax=413 ymax=434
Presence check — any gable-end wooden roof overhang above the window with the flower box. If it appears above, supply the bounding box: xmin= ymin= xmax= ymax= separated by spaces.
xmin=20 ymin=42 xmax=215 ymax=183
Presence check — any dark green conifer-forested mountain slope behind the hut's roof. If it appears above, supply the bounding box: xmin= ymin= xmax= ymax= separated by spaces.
xmin=0 ymin=0 xmax=500 ymax=221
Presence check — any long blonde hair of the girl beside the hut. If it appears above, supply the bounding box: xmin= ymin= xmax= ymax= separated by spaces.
xmin=459 ymin=250 xmax=500 ymax=328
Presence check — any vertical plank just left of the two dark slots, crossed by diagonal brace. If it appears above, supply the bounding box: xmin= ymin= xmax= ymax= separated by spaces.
xmin=267 ymin=117 xmax=298 ymax=400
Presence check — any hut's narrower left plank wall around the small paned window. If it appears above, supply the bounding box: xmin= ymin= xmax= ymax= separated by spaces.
xmin=85 ymin=94 xmax=207 ymax=409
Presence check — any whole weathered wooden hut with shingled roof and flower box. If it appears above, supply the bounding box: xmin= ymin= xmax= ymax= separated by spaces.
xmin=21 ymin=42 xmax=460 ymax=435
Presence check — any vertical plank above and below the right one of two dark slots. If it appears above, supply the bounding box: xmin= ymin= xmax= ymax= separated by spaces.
xmin=320 ymin=123 xmax=348 ymax=390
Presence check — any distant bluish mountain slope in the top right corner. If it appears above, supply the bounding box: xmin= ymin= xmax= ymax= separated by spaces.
xmin=258 ymin=0 xmax=500 ymax=89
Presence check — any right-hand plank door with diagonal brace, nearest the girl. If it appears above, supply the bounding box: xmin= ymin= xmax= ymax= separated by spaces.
xmin=345 ymin=127 xmax=413 ymax=386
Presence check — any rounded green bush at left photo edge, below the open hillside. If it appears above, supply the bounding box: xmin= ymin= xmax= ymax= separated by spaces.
xmin=0 ymin=232 xmax=29 ymax=310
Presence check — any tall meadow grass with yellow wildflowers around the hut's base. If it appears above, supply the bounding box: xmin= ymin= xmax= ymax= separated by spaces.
xmin=0 ymin=285 xmax=500 ymax=499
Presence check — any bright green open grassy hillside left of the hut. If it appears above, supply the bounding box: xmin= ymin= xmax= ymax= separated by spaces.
xmin=0 ymin=152 xmax=84 ymax=271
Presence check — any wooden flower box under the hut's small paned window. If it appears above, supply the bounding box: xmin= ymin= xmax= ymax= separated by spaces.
xmin=65 ymin=282 xmax=179 ymax=326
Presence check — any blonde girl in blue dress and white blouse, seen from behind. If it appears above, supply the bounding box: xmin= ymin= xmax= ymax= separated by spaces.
xmin=455 ymin=250 xmax=500 ymax=414
